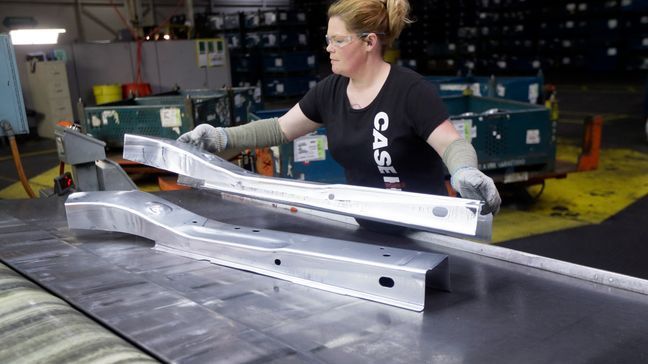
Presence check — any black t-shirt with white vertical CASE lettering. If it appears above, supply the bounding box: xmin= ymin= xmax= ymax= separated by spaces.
xmin=299 ymin=65 xmax=448 ymax=195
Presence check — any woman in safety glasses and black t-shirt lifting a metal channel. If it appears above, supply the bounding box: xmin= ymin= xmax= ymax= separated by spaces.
xmin=178 ymin=0 xmax=501 ymax=226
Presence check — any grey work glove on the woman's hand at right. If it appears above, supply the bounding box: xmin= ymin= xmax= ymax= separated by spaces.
xmin=450 ymin=167 xmax=502 ymax=215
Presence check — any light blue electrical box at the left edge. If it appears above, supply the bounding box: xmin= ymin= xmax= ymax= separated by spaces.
xmin=0 ymin=34 xmax=29 ymax=135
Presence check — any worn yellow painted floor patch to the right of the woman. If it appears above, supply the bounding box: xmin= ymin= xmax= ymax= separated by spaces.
xmin=493 ymin=144 xmax=648 ymax=243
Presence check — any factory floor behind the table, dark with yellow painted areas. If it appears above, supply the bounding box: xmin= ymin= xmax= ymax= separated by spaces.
xmin=0 ymin=83 xmax=648 ymax=279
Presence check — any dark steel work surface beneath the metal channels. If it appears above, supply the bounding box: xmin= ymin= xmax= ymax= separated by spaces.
xmin=0 ymin=190 xmax=648 ymax=363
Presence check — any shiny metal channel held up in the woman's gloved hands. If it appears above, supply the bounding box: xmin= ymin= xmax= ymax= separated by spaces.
xmin=123 ymin=134 xmax=492 ymax=240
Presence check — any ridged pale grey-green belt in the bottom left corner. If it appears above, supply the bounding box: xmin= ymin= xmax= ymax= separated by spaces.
xmin=0 ymin=264 xmax=156 ymax=363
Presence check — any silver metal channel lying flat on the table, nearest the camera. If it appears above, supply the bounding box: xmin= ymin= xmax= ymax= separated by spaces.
xmin=65 ymin=191 xmax=450 ymax=311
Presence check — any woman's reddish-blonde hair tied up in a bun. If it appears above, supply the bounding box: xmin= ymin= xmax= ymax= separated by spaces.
xmin=328 ymin=0 xmax=412 ymax=51
